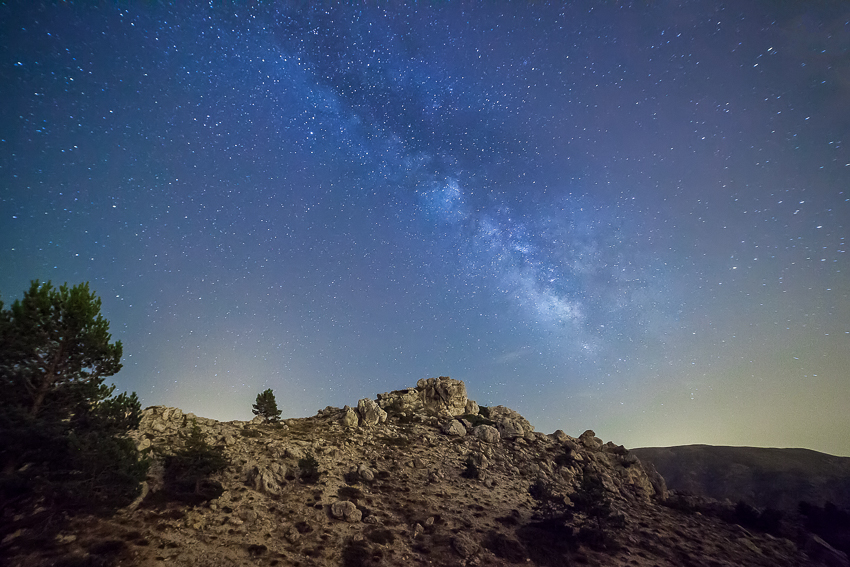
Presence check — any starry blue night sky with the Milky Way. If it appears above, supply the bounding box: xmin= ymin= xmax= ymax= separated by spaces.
xmin=0 ymin=0 xmax=850 ymax=455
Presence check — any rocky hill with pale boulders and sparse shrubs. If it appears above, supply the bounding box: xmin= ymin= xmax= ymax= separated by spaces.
xmin=4 ymin=377 xmax=846 ymax=567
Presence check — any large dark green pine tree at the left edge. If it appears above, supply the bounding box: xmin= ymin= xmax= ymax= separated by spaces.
xmin=0 ymin=281 xmax=149 ymax=510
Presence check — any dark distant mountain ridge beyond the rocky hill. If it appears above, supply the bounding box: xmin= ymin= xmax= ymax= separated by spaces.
xmin=631 ymin=445 xmax=850 ymax=511
